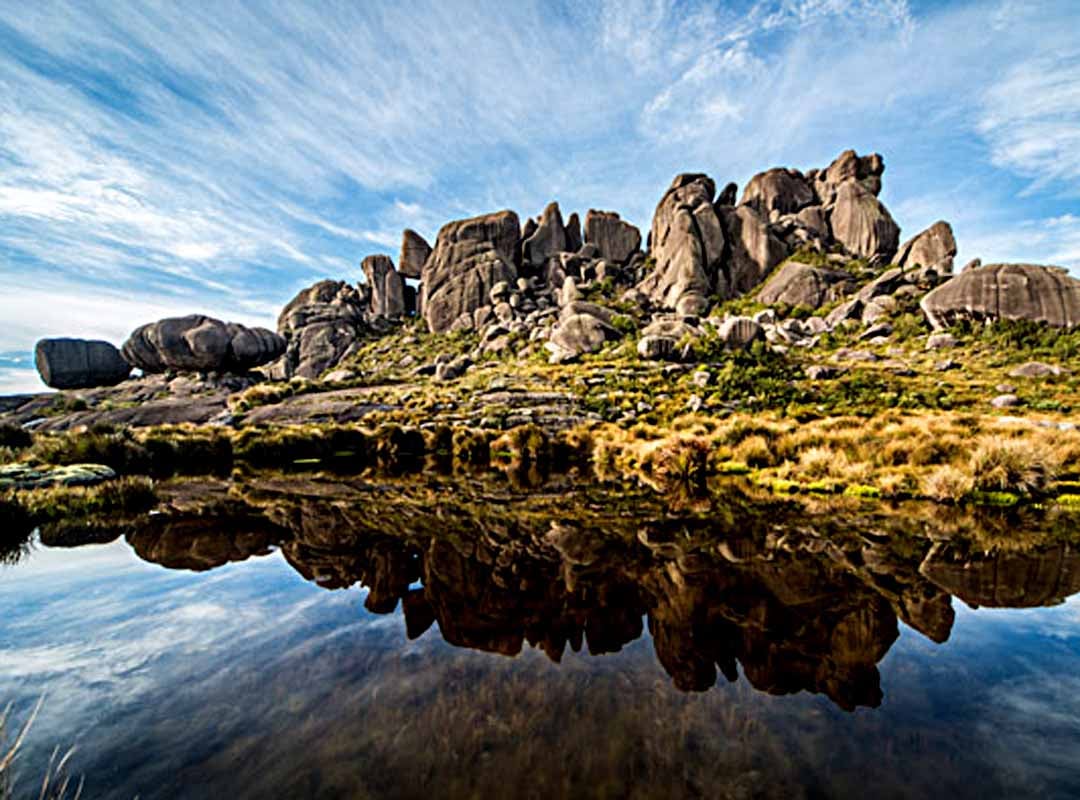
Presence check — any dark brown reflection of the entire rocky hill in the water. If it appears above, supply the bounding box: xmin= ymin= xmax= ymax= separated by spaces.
xmin=33 ymin=479 xmax=1080 ymax=711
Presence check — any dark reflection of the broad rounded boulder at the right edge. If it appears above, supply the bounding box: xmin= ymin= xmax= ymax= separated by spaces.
xmin=919 ymin=543 xmax=1080 ymax=608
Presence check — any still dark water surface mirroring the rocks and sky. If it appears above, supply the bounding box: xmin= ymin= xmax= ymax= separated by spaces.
xmin=0 ymin=480 xmax=1080 ymax=798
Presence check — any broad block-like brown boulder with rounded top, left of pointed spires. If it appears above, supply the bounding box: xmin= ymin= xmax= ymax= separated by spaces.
xmin=421 ymin=211 xmax=521 ymax=334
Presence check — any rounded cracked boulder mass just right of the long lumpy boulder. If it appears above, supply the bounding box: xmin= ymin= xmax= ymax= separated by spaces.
xmin=278 ymin=281 xmax=368 ymax=378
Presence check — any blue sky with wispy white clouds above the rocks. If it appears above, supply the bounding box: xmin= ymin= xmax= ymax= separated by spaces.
xmin=0 ymin=0 xmax=1080 ymax=392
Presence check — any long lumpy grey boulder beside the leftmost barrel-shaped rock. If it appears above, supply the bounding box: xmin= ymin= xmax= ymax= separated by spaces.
xmin=122 ymin=314 xmax=285 ymax=372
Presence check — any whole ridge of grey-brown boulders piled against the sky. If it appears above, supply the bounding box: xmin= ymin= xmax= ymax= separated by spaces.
xmin=29 ymin=150 xmax=1080 ymax=389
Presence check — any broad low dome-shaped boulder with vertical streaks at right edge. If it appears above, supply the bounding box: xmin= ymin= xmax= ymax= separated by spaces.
xmin=921 ymin=263 xmax=1080 ymax=329
